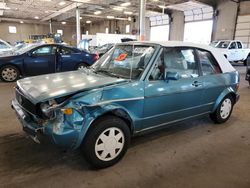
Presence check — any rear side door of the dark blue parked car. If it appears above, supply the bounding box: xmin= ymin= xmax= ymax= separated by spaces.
xmin=57 ymin=46 xmax=81 ymax=72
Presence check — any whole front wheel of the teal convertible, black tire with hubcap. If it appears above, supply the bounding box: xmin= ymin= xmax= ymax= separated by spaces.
xmin=82 ymin=115 xmax=131 ymax=169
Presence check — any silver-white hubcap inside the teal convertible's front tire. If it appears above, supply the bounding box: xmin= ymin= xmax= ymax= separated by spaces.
xmin=95 ymin=127 xmax=125 ymax=161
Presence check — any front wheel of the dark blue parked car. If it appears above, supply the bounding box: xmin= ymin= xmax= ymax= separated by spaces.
xmin=0 ymin=65 xmax=20 ymax=82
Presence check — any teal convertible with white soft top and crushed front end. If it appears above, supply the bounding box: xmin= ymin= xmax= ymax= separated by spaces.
xmin=12 ymin=42 xmax=239 ymax=168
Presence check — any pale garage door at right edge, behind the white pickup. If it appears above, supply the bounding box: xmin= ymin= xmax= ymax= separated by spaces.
xmin=235 ymin=15 xmax=250 ymax=48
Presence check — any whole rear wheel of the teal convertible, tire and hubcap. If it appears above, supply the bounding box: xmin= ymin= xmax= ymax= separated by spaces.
xmin=210 ymin=95 xmax=234 ymax=123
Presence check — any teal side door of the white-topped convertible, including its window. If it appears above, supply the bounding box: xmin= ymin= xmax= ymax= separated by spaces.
xmin=142 ymin=47 xmax=204 ymax=129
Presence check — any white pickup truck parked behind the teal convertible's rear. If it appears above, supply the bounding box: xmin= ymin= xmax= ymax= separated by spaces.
xmin=211 ymin=40 xmax=250 ymax=66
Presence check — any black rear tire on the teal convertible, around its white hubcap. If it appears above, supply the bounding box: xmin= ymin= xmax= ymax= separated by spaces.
xmin=210 ymin=95 xmax=235 ymax=124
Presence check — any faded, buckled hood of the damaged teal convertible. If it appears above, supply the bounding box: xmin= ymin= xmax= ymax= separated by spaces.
xmin=17 ymin=70 xmax=127 ymax=104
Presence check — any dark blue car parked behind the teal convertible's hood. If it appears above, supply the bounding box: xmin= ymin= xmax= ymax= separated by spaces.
xmin=0 ymin=44 xmax=99 ymax=82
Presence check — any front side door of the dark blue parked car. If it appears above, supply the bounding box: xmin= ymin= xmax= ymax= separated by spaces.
xmin=24 ymin=45 xmax=56 ymax=76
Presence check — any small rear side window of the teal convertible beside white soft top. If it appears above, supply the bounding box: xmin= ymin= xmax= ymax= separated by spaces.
xmin=198 ymin=50 xmax=221 ymax=76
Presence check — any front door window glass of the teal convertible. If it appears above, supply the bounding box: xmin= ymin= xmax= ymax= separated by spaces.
xmin=164 ymin=48 xmax=199 ymax=79
